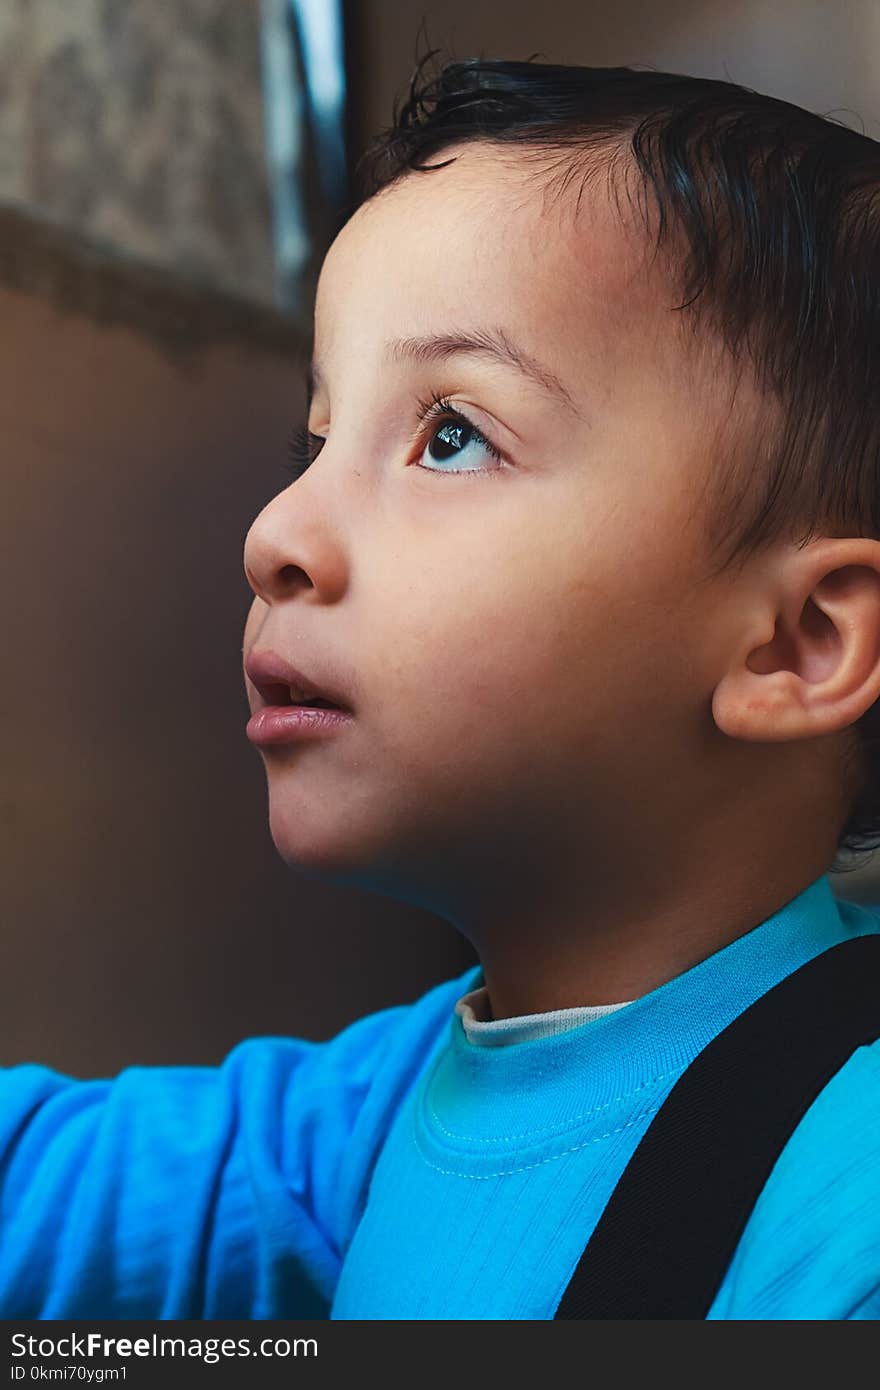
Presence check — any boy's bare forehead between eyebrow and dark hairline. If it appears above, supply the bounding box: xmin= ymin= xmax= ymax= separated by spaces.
xmin=316 ymin=143 xmax=656 ymax=385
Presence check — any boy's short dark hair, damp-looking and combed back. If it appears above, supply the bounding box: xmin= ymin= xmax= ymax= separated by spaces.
xmin=355 ymin=49 xmax=880 ymax=872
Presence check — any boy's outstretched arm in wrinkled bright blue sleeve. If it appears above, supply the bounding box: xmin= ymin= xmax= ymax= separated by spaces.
xmin=0 ymin=980 xmax=462 ymax=1319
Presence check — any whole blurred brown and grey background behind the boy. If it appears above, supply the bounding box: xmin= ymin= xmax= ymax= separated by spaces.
xmin=0 ymin=0 xmax=880 ymax=1076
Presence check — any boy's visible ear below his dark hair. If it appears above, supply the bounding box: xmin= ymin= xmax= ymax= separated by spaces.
xmin=712 ymin=537 xmax=880 ymax=742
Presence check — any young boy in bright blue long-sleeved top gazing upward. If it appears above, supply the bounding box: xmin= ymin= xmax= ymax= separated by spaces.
xmin=0 ymin=51 xmax=880 ymax=1319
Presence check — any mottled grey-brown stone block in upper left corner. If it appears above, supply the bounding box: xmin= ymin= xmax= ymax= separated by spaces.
xmin=0 ymin=0 xmax=274 ymax=303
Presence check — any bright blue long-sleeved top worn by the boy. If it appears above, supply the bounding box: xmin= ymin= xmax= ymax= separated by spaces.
xmin=0 ymin=874 xmax=880 ymax=1319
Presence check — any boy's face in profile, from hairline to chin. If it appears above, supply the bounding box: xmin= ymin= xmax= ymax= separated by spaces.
xmin=245 ymin=146 xmax=720 ymax=924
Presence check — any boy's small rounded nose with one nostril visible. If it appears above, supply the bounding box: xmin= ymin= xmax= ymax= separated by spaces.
xmin=245 ymin=482 xmax=346 ymax=605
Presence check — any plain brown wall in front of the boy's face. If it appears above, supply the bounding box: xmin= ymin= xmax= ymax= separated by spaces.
xmin=0 ymin=230 xmax=471 ymax=1076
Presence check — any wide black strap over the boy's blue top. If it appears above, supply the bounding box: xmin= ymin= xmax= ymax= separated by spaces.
xmin=555 ymin=935 xmax=880 ymax=1318
